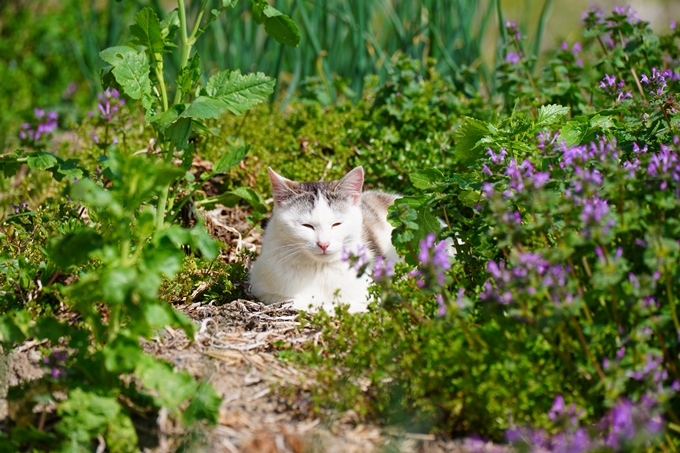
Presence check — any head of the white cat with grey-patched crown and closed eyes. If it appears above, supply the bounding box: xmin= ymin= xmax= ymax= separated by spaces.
xmin=269 ymin=167 xmax=364 ymax=262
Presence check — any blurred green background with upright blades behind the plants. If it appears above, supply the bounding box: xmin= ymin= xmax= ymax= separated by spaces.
xmin=0 ymin=0 xmax=680 ymax=149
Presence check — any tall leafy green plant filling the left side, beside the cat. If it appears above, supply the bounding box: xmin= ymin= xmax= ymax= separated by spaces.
xmin=0 ymin=1 xmax=299 ymax=446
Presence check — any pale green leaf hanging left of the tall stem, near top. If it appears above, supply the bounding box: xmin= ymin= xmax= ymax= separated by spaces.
xmin=99 ymin=46 xmax=151 ymax=99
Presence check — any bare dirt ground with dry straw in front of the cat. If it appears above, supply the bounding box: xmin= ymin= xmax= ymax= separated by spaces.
xmin=0 ymin=203 xmax=498 ymax=453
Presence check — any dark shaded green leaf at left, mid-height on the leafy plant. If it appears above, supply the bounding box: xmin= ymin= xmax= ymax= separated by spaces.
xmin=47 ymin=228 xmax=104 ymax=269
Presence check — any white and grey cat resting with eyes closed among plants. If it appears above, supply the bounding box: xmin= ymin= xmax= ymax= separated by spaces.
xmin=250 ymin=167 xmax=399 ymax=313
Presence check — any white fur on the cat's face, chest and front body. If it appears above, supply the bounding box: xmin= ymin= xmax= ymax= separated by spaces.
xmin=250 ymin=197 xmax=372 ymax=312
